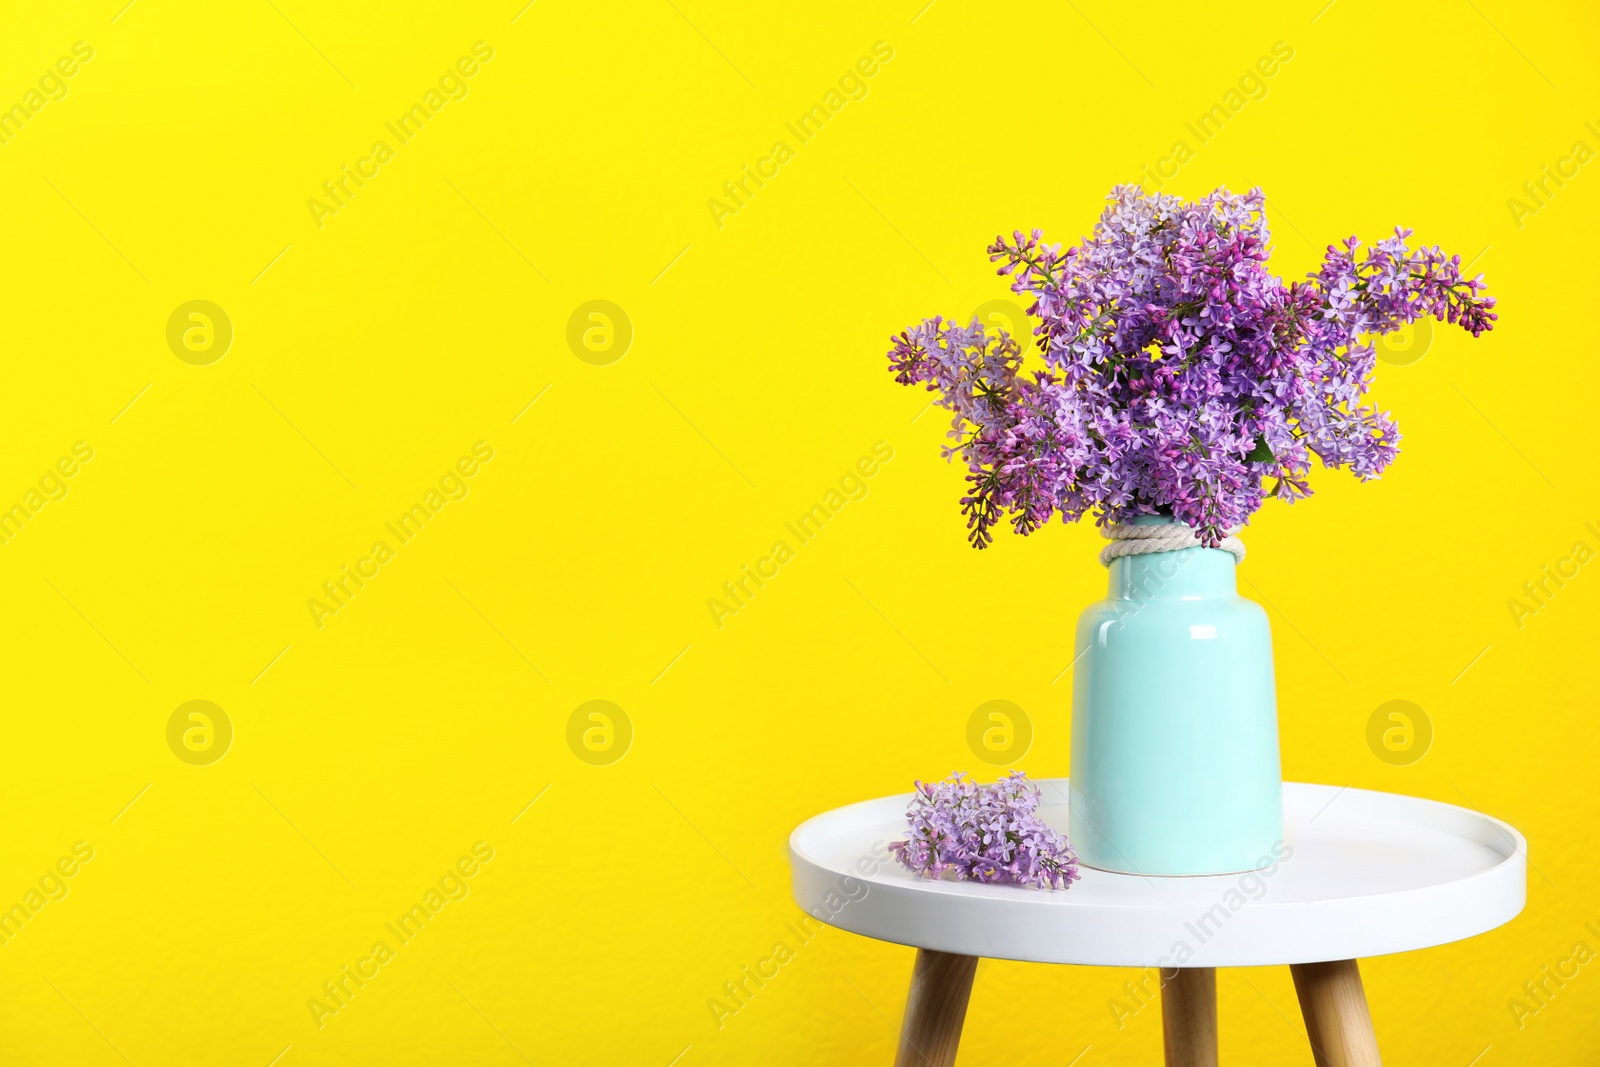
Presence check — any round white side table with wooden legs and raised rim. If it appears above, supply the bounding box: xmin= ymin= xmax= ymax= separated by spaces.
xmin=789 ymin=779 xmax=1526 ymax=1067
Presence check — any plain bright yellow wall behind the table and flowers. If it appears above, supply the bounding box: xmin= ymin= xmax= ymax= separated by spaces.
xmin=0 ymin=0 xmax=1600 ymax=1067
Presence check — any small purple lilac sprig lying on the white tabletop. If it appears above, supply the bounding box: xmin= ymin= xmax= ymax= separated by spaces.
xmin=890 ymin=771 xmax=1078 ymax=889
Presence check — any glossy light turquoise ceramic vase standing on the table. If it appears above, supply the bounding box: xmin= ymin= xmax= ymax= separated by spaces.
xmin=1067 ymin=515 xmax=1283 ymax=875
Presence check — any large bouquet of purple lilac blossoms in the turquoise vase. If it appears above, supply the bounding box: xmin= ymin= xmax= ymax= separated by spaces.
xmin=890 ymin=186 xmax=1496 ymax=549
